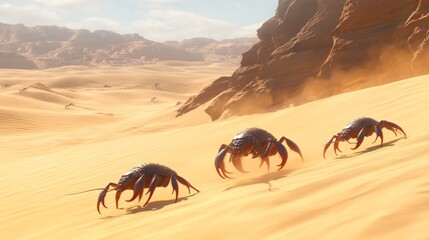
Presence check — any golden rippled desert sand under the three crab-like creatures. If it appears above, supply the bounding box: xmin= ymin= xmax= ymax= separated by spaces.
xmin=0 ymin=62 xmax=429 ymax=239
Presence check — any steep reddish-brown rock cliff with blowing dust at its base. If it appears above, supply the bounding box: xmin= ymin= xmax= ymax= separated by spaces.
xmin=178 ymin=0 xmax=429 ymax=120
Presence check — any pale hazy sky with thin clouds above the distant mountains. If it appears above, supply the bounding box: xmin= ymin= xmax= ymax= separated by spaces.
xmin=0 ymin=0 xmax=278 ymax=41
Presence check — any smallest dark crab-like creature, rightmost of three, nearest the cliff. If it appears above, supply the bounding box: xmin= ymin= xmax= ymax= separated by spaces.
xmin=323 ymin=117 xmax=407 ymax=158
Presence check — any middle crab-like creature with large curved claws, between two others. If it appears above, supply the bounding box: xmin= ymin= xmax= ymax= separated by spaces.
xmin=215 ymin=128 xmax=304 ymax=178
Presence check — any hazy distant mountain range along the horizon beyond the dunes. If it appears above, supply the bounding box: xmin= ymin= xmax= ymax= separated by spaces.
xmin=0 ymin=23 xmax=257 ymax=69
